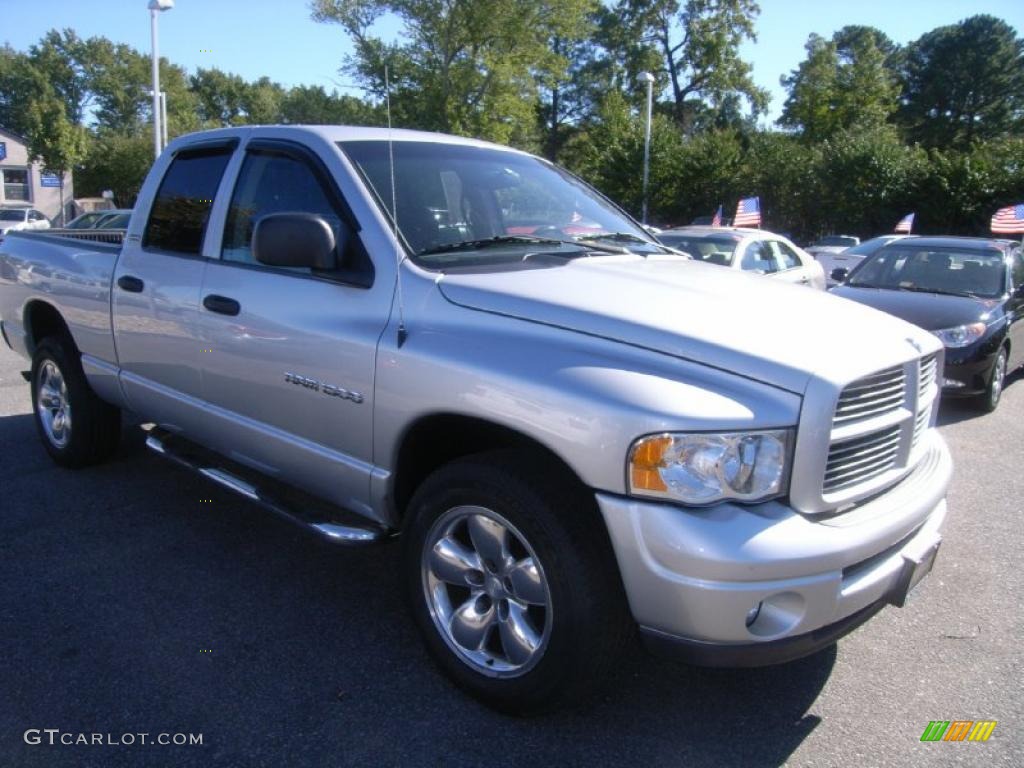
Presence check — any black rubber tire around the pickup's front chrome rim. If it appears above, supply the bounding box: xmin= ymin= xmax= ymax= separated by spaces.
xmin=402 ymin=452 xmax=635 ymax=715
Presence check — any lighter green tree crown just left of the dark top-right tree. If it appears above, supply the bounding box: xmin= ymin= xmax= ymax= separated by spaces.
xmin=779 ymin=27 xmax=899 ymax=141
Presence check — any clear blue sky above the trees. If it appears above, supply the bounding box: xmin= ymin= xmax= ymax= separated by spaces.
xmin=0 ymin=0 xmax=1024 ymax=118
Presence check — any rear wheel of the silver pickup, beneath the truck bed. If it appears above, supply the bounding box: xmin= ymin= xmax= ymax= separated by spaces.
xmin=32 ymin=336 xmax=121 ymax=468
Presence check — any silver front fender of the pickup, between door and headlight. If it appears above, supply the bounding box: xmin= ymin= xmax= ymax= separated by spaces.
xmin=374 ymin=274 xmax=800 ymax=528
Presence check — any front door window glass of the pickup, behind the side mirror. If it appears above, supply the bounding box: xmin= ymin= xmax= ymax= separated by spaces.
xmin=221 ymin=152 xmax=342 ymax=272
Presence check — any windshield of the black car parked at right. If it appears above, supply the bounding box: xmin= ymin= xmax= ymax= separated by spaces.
xmin=847 ymin=246 xmax=1007 ymax=298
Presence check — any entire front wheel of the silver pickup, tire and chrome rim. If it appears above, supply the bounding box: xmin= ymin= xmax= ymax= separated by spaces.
xmin=403 ymin=452 xmax=633 ymax=715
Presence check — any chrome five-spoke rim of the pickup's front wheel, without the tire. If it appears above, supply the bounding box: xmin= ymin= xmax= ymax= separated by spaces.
xmin=421 ymin=507 xmax=552 ymax=677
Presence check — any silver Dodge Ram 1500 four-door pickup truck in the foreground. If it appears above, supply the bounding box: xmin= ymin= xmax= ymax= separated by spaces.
xmin=0 ymin=127 xmax=951 ymax=713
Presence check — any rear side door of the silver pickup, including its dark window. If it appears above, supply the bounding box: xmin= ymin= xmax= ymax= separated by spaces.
xmin=112 ymin=142 xmax=237 ymax=433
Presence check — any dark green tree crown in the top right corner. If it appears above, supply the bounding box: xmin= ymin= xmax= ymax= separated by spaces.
xmin=899 ymin=15 xmax=1024 ymax=146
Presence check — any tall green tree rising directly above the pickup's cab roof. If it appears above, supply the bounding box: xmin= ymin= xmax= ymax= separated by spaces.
xmin=312 ymin=0 xmax=590 ymax=145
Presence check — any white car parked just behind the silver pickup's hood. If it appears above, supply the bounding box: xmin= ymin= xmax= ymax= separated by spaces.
xmin=657 ymin=226 xmax=825 ymax=290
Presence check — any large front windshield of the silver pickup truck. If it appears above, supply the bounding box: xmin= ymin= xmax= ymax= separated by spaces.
xmin=339 ymin=140 xmax=663 ymax=268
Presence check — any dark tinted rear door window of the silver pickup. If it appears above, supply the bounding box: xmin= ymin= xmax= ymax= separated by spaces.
xmin=142 ymin=147 xmax=232 ymax=254
